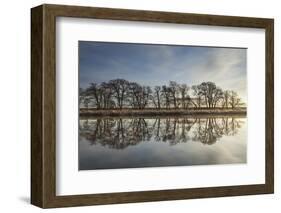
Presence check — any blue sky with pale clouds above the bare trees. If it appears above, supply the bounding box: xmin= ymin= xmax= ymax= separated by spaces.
xmin=79 ymin=41 xmax=247 ymax=102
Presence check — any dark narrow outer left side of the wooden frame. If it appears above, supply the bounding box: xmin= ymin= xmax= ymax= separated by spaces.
xmin=31 ymin=6 xmax=44 ymax=206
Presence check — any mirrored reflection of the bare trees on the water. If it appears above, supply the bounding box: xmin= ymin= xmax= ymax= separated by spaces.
xmin=79 ymin=117 xmax=244 ymax=149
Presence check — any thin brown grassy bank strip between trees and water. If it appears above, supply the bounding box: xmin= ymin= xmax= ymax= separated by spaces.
xmin=80 ymin=108 xmax=247 ymax=117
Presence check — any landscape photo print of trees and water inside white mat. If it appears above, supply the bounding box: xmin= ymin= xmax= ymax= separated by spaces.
xmin=78 ymin=41 xmax=247 ymax=170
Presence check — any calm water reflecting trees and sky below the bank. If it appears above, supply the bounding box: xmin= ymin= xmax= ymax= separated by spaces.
xmin=79 ymin=117 xmax=247 ymax=170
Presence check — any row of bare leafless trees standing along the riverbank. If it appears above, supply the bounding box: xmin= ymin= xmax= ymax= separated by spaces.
xmin=79 ymin=79 xmax=245 ymax=110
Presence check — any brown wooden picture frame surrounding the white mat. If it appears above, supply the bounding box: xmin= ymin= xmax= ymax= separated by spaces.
xmin=31 ymin=4 xmax=274 ymax=208
